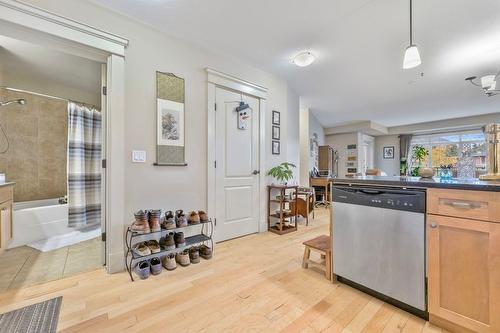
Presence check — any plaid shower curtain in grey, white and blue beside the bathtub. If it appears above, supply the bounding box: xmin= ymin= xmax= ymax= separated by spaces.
xmin=68 ymin=102 xmax=101 ymax=227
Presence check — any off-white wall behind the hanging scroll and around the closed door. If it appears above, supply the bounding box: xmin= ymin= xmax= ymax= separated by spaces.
xmin=28 ymin=0 xmax=298 ymax=268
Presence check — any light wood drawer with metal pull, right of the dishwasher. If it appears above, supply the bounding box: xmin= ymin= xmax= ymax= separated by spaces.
xmin=427 ymin=189 xmax=500 ymax=222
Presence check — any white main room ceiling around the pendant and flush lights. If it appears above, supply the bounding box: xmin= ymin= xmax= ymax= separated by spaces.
xmin=93 ymin=0 xmax=500 ymax=127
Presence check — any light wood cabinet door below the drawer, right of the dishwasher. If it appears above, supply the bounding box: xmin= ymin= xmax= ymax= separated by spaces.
xmin=427 ymin=215 xmax=500 ymax=333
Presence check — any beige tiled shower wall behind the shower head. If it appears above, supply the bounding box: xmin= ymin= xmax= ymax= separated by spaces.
xmin=0 ymin=88 xmax=68 ymax=202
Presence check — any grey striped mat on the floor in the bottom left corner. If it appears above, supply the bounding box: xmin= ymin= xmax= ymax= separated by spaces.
xmin=0 ymin=296 xmax=62 ymax=333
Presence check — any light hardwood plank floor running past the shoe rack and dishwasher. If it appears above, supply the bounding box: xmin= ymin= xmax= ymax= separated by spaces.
xmin=0 ymin=208 xmax=444 ymax=333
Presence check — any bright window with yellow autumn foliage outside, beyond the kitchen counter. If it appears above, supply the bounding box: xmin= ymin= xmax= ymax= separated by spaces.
xmin=410 ymin=131 xmax=487 ymax=178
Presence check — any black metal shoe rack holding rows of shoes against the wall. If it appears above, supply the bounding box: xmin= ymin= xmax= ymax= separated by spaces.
xmin=125 ymin=219 xmax=214 ymax=281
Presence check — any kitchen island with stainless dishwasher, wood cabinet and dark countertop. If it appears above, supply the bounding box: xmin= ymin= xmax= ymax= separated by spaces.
xmin=331 ymin=176 xmax=500 ymax=333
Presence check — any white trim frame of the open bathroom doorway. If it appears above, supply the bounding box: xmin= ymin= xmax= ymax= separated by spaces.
xmin=0 ymin=0 xmax=128 ymax=273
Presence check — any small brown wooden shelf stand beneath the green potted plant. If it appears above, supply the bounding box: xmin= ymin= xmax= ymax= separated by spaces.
xmin=267 ymin=185 xmax=299 ymax=235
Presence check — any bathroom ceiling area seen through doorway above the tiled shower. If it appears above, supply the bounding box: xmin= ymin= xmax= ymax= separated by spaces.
xmin=0 ymin=35 xmax=101 ymax=105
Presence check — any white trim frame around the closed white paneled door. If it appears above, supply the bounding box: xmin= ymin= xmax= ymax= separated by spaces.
xmin=205 ymin=68 xmax=268 ymax=237
